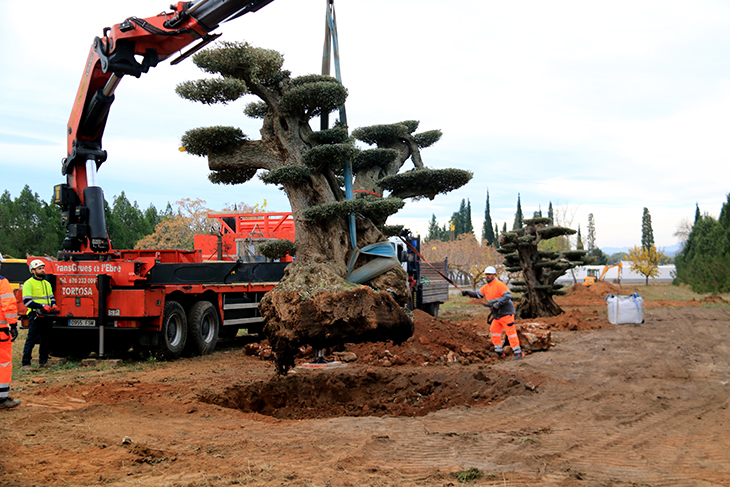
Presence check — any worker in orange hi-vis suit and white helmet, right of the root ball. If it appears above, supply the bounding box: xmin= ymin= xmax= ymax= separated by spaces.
xmin=461 ymin=266 xmax=523 ymax=360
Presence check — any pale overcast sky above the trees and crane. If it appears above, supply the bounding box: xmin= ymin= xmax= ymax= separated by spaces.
xmin=0 ymin=0 xmax=730 ymax=252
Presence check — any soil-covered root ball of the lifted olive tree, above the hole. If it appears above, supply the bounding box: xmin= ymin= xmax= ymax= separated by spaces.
xmin=259 ymin=264 xmax=414 ymax=374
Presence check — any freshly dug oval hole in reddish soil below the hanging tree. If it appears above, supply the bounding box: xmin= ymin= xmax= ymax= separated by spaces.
xmin=199 ymin=367 xmax=534 ymax=419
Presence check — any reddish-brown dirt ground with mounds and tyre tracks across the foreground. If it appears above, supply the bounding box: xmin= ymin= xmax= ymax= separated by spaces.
xmin=0 ymin=283 xmax=730 ymax=487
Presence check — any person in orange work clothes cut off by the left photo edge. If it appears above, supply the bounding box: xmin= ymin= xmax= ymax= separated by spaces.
xmin=0 ymin=254 xmax=20 ymax=409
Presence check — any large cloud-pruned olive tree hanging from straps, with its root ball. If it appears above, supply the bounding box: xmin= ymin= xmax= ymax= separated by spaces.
xmin=176 ymin=42 xmax=472 ymax=373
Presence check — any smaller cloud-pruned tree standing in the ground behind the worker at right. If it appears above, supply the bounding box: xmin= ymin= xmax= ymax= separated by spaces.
xmin=498 ymin=218 xmax=589 ymax=318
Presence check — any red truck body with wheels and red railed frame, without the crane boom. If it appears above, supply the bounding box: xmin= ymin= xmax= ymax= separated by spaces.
xmin=17 ymin=213 xmax=294 ymax=358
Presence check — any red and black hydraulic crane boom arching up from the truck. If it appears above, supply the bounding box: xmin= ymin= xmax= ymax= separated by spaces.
xmin=54 ymin=0 xmax=273 ymax=253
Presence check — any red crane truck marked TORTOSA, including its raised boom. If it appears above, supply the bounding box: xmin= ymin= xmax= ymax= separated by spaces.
xmin=22 ymin=0 xmax=278 ymax=357
